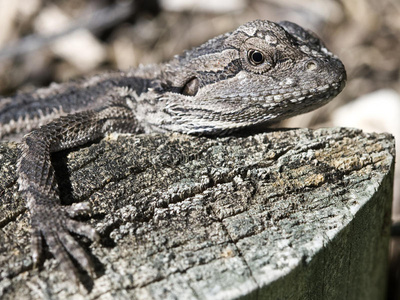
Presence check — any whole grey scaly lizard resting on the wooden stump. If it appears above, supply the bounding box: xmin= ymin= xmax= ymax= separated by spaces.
xmin=0 ymin=20 xmax=346 ymax=281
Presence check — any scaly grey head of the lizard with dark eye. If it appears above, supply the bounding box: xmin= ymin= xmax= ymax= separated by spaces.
xmin=148 ymin=20 xmax=346 ymax=134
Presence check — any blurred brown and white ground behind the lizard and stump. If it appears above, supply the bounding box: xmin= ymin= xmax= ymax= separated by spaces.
xmin=0 ymin=0 xmax=400 ymax=299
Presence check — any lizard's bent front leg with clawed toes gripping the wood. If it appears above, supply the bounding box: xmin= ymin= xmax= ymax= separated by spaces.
xmin=18 ymin=95 xmax=141 ymax=281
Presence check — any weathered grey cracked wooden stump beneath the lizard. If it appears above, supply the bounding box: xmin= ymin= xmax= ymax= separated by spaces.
xmin=0 ymin=128 xmax=394 ymax=299
